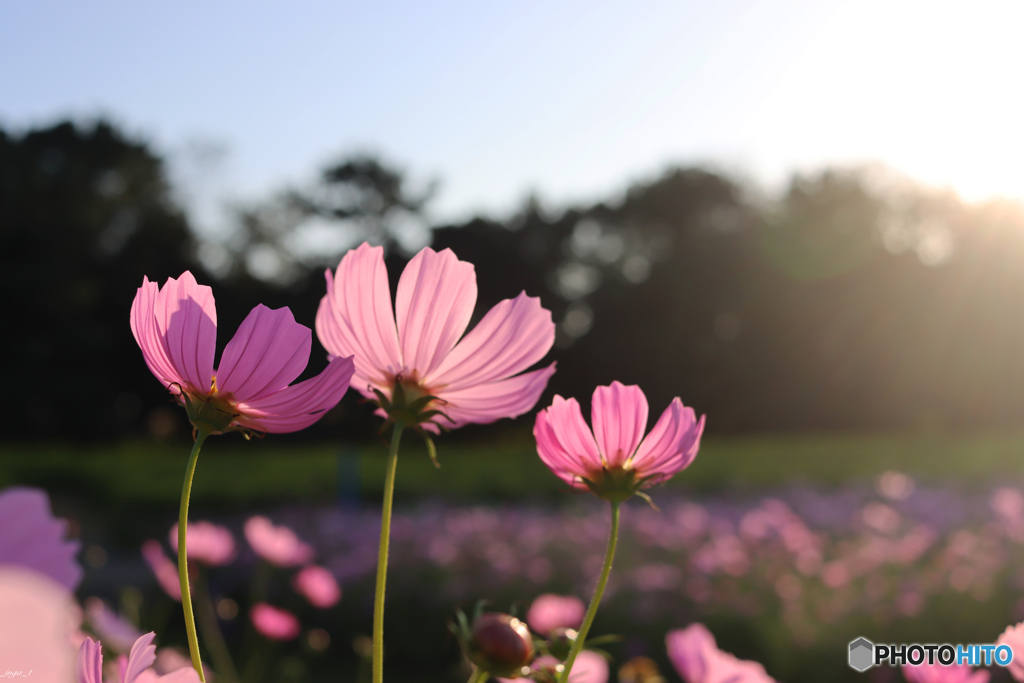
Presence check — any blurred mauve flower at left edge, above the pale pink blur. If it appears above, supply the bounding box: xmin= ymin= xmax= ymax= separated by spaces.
xmin=0 ymin=486 xmax=82 ymax=589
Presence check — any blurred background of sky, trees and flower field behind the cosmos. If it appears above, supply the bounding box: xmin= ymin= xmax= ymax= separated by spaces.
xmin=0 ymin=0 xmax=1024 ymax=682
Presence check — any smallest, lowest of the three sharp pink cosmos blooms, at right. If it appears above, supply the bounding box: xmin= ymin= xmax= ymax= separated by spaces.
xmin=534 ymin=382 xmax=705 ymax=500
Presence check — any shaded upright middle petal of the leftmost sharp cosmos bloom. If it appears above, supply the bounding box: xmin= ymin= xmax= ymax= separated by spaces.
xmin=217 ymin=304 xmax=312 ymax=402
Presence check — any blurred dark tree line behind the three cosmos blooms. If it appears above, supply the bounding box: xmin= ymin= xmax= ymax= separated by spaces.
xmin=6 ymin=123 xmax=1024 ymax=442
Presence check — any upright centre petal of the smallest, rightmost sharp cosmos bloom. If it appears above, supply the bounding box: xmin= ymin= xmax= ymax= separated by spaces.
xmin=590 ymin=382 xmax=647 ymax=467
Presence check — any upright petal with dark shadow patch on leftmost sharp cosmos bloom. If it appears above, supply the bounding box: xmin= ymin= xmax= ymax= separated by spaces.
xmin=153 ymin=270 xmax=217 ymax=393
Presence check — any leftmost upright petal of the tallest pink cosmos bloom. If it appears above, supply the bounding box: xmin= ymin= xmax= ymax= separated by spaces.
xmin=316 ymin=243 xmax=402 ymax=397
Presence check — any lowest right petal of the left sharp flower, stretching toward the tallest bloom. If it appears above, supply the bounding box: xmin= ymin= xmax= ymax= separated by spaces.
xmin=237 ymin=356 xmax=355 ymax=434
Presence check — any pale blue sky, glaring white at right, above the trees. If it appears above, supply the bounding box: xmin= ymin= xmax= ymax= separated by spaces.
xmin=0 ymin=0 xmax=1024 ymax=229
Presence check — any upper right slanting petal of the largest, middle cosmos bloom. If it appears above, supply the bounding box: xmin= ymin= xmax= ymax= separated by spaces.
xmin=425 ymin=292 xmax=555 ymax=391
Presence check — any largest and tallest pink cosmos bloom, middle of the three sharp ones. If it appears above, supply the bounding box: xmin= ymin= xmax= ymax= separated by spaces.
xmin=316 ymin=243 xmax=555 ymax=431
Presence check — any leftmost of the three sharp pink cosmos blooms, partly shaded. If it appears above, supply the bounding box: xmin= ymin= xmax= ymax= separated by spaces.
xmin=131 ymin=271 xmax=353 ymax=433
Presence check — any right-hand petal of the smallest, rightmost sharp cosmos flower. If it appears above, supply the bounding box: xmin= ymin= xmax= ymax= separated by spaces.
xmin=633 ymin=397 xmax=705 ymax=480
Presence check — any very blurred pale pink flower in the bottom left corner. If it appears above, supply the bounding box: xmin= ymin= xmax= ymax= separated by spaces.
xmin=0 ymin=565 xmax=79 ymax=683
